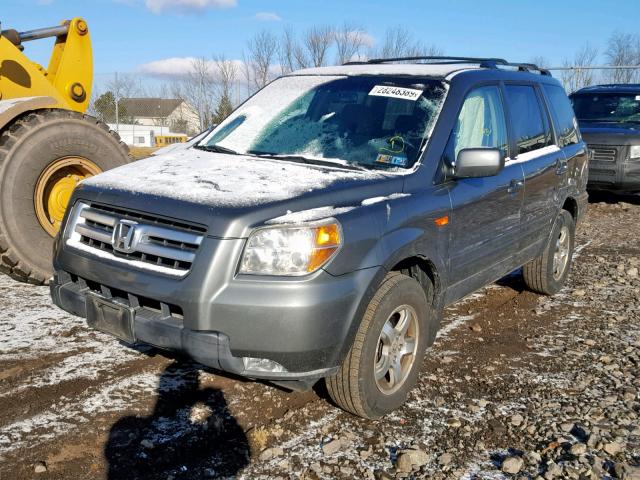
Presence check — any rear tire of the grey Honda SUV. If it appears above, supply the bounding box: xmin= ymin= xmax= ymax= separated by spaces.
xmin=522 ymin=210 xmax=576 ymax=295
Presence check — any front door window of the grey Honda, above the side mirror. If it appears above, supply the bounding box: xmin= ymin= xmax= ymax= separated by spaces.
xmin=445 ymin=85 xmax=507 ymax=164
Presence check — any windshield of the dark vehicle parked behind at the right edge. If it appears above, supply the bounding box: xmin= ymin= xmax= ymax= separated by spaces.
xmin=571 ymin=93 xmax=640 ymax=123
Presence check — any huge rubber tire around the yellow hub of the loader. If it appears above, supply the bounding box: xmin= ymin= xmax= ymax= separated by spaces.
xmin=0 ymin=110 xmax=131 ymax=284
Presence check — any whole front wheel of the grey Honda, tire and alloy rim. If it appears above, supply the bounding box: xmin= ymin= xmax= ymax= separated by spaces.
xmin=326 ymin=272 xmax=435 ymax=418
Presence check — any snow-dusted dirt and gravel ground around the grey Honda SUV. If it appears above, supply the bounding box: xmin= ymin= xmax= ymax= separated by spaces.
xmin=0 ymin=195 xmax=640 ymax=480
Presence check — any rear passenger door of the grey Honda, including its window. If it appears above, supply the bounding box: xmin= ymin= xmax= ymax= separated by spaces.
xmin=505 ymin=83 xmax=567 ymax=255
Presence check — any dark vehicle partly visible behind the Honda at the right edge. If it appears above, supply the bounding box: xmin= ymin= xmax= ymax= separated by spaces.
xmin=571 ymin=84 xmax=640 ymax=193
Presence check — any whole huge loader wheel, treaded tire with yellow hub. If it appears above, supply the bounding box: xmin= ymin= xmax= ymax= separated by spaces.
xmin=0 ymin=110 xmax=130 ymax=284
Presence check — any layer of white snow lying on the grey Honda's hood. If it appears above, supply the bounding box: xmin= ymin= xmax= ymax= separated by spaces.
xmin=82 ymin=149 xmax=382 ymax=207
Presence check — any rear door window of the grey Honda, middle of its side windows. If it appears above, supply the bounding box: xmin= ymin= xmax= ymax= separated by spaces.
xmin=506 ymin=85 xmax=551 ymax=156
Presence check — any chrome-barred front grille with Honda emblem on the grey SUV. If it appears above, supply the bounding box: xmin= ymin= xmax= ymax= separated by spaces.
xmin=67 ymin=202 xmax=206 ymax=276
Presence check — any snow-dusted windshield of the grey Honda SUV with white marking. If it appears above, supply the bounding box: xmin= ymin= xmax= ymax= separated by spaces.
xmin=200 ymin=76 xmax=446 ymax=169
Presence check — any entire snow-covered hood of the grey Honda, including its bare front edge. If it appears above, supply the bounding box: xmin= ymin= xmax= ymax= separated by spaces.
xmin=72 ymin=149 xmax=404 ymax=238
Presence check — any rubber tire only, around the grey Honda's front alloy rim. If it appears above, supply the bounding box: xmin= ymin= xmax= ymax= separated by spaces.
xmin=326 ymin=272 xmax=439 ymax=419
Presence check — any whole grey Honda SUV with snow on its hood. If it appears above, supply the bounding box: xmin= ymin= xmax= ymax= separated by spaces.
xmin=51 ymin=57 xmax=587 ymax=418
